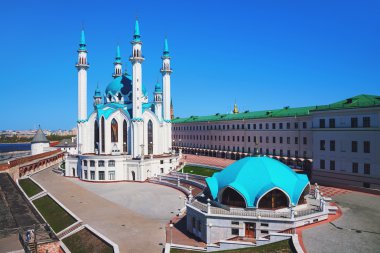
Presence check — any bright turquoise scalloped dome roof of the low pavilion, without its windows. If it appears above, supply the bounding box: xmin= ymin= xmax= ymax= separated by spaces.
xmin=206 ymin=157 xmax=310 ymax=208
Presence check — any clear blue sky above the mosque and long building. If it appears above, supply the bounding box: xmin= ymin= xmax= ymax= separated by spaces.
xmin=0 ymin=0 xmax=380 ymax=130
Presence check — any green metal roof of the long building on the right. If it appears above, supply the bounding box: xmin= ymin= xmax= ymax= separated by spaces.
xmin=172 ymin=95 xmax=380 ymax=124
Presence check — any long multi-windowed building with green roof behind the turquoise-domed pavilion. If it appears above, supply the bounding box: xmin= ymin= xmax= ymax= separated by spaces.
xmin=173 ymin=95 xmax=380 ymax=189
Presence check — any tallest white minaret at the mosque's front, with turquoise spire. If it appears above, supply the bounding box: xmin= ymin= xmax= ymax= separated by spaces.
xmin=129 ymin=19 xmax=145 ymax=119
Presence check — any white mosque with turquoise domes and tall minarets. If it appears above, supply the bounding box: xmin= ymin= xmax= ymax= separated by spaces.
xmin=65 ymin=20 xmax=178 ymax=181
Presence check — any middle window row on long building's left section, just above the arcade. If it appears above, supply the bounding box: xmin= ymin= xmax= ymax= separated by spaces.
xmin=173 ymin=135 xmax=307 ymax=145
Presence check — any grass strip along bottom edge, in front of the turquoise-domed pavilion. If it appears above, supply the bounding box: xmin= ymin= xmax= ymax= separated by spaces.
xmin=170 ymin=240 xmax=293 ymax=253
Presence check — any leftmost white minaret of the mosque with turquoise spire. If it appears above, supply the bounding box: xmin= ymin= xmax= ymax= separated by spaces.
xmin=75 ymin=30 xmax=90 ymax=121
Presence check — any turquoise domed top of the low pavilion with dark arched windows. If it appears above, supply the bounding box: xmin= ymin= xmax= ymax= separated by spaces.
xmin=206 ymin=157 xmax=310 ymax=209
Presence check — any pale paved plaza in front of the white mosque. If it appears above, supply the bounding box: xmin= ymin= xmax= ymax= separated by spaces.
xmin=32 ymin=169 xmax=183 ymax=252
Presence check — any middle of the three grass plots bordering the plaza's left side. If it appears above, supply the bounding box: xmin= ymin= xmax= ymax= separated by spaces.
xmin=33 ymin=195 xmax=76 ymax=233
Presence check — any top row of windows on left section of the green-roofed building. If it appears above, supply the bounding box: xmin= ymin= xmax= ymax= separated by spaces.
xmin=174 ymin=121 xmax=307 ymax=131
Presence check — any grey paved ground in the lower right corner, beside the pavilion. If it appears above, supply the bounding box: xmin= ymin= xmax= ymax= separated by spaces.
xmin=302 ymin=191 xmax=380 ymax=253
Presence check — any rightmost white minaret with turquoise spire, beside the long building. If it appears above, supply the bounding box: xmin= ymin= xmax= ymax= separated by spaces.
xmin=161 ymin=38 xmax=172 ymax=121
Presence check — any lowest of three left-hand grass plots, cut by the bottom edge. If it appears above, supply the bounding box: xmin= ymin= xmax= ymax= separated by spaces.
xmin=62 ymin=229 xmax=113 ymax=253
